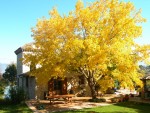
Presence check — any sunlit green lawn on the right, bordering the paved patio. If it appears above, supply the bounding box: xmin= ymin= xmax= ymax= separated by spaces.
xmin=57 ymin=102 xmax=150 ymax=113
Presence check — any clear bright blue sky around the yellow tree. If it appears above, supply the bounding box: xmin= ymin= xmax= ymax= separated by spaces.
xmin=0 ymin=0 xmax=150 ymax=63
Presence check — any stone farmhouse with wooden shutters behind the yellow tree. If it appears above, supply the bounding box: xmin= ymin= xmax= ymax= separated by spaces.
xmin=15 ymin=44 xmax=91 ymax=99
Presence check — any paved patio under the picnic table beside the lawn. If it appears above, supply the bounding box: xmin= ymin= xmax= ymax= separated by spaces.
xmin=26 ymin=97 xmax=113 ymax=113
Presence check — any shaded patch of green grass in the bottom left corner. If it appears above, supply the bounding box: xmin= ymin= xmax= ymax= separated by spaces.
xmin=0 ymin=99 xmax=32 ymax=113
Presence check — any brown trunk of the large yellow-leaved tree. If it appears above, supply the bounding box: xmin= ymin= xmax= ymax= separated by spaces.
xmin=87 ymin=76 xmax=97 ymax=99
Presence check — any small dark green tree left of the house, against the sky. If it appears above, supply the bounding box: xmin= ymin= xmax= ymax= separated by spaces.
xmin=3 ymin=64 xmax=17 ymax=85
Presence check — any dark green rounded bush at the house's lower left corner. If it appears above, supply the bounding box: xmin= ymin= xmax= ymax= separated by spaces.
xmin=6 ymin=86 xmax=26 ymax=104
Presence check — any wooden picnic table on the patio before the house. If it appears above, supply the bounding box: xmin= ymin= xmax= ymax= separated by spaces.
xmin=46 ymin=94 xmax=75 ymax=104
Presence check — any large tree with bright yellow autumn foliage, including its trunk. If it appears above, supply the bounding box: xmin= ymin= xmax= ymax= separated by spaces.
xmin=24 ymin=0 xmax=149 ymax=99
